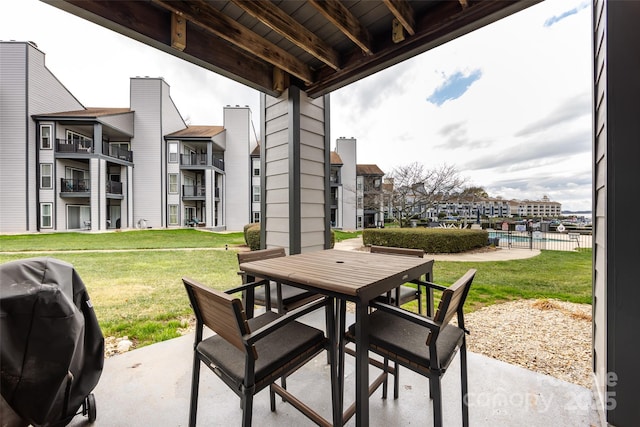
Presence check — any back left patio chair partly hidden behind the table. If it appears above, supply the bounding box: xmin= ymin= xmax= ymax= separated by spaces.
xmin=238 ymin=248 xmax=322 ymax=317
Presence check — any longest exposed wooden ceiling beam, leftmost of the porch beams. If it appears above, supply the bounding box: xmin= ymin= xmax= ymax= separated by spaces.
xmin=153 ymin=0 xmax=313 ymax=84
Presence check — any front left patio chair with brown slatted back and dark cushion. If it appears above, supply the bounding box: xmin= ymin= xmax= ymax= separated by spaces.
xmin=182 ymin=277 xmax=336 ymax=427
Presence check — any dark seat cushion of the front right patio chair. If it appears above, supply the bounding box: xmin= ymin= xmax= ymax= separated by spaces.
xmin=347 ymin=310 xmax=464 ymax=374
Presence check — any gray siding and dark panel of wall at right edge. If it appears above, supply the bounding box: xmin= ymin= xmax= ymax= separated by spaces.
xmin=593 ymin=0 xmax=640 ymax=426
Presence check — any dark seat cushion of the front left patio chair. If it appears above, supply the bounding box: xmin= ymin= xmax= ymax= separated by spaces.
xmin=196 ymin=311 xmax=326 ymax=391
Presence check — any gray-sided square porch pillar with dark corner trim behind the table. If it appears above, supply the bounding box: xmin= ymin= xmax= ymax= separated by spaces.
xmin=261 ymin=88 xmax=329 ymax=253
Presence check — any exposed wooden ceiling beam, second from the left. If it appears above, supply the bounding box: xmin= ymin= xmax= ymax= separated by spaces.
xmin=232 ymin=0 xmax=340 ymax=70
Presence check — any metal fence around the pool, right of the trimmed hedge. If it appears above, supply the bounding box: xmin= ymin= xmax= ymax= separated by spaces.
xmin=487 ymin=230 xmax=592 ymax=251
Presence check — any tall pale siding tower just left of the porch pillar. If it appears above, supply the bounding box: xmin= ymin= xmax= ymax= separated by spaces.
xmin=224 ymin=106 xmax=251 ymax=231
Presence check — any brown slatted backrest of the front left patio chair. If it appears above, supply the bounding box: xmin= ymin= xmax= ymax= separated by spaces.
xmin=182 ymin=277 xmax=255 ymax=354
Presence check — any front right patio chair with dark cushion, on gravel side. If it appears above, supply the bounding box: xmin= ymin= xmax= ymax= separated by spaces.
xmin=346 ymin=269 xmax=476 ymax=427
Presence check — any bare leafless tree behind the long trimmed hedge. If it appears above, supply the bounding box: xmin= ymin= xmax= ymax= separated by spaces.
xmin=389 ymin=162 xmax=466 ymax=227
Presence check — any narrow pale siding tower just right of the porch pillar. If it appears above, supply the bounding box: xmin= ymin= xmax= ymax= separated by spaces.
xmin=336 ymin=138 xmax=362 ymax=230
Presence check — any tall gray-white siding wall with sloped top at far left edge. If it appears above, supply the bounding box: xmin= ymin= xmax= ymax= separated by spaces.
xmin=0 ymin=42 xmax=83 ymax=232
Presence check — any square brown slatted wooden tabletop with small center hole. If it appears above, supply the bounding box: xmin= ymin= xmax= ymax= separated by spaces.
xmin=240 ymin=249 xmax=433 ymax=298
